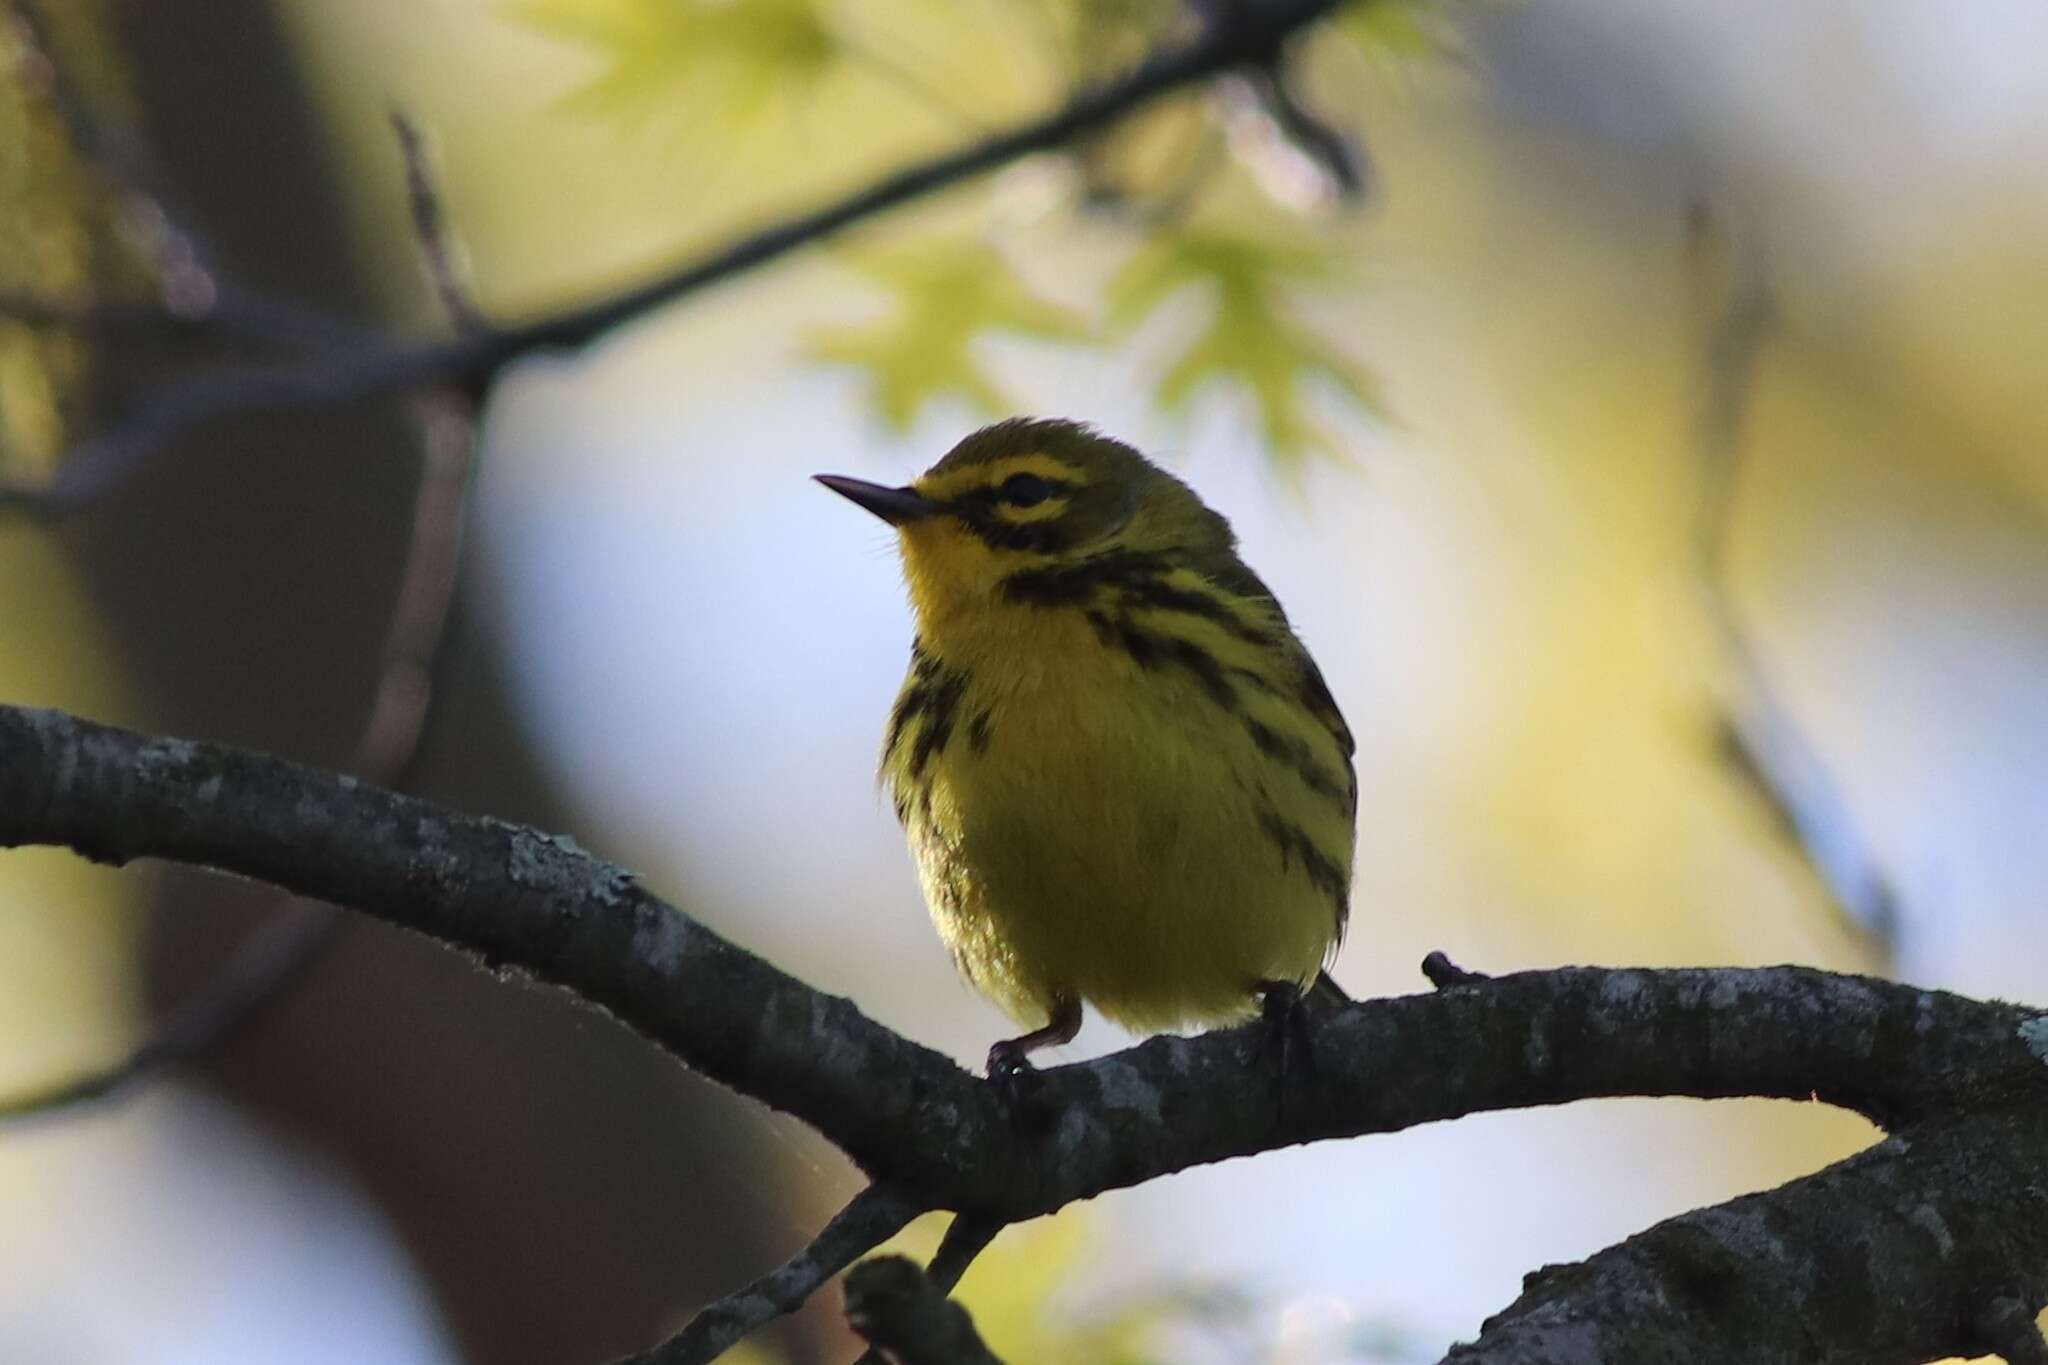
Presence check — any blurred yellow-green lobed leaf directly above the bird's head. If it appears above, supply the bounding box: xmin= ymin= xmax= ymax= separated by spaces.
xmin=807 ymin=241 xmax=1092 ymax=430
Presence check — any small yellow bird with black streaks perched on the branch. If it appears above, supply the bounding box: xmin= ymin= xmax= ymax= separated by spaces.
xmin=817 ymin=417 xmax=1358 ymax=1078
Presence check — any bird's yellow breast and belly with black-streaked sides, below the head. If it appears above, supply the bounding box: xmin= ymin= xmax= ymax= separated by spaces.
xmin=883 ymin=577 xmax=1352 ymax=1029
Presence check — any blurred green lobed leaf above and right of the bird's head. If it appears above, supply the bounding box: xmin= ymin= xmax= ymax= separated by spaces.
xmin=1110 ymin=229 xmax=1382 ymax=456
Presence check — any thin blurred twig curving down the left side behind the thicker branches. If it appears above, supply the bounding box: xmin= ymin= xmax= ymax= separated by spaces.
xmin=0 ymin=121 xmax=479 ymax=1121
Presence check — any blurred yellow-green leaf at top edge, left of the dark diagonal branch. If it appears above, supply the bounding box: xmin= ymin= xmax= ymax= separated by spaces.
xmin=508 ymin=0 xmax=846 ymax=123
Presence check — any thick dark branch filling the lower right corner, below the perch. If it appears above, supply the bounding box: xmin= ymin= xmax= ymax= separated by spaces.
xmin=1446 ymin=1111 xmax=2048 ymax=1365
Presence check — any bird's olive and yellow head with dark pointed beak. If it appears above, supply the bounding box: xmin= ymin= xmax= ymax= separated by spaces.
xmin=817 ymin=417 xmax=1235 ymax=624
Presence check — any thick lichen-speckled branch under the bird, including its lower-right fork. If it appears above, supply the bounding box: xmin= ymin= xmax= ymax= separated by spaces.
xmin=0 ymin=708 xmax=2048 ymax=1365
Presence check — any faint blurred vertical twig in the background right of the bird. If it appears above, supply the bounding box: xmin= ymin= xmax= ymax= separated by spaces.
xmin=1688 ymin=209 xmax=1898 ymax=962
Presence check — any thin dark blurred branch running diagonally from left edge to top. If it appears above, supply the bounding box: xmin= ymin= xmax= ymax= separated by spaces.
xmin=0 ymin=0 xmax=1339 ymax=516
